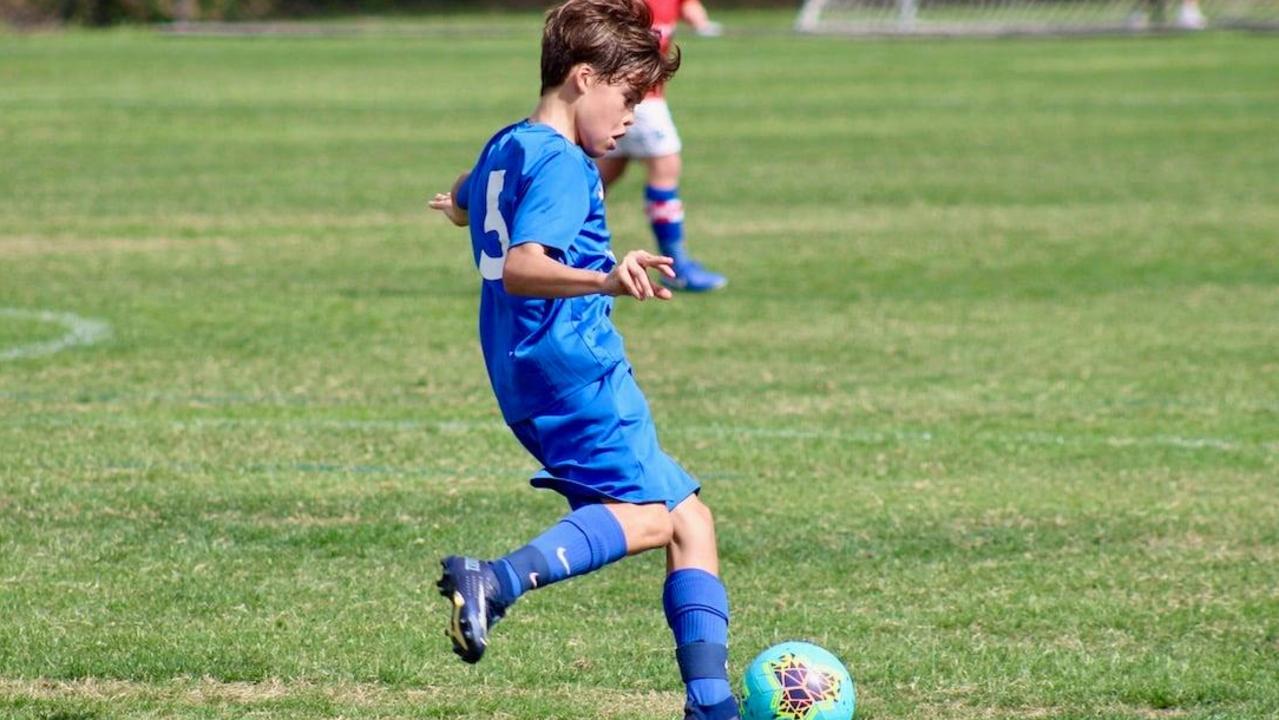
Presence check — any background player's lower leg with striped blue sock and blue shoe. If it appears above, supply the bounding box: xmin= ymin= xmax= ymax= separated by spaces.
xmin=643 ymin=152 xmax=728 ymax=292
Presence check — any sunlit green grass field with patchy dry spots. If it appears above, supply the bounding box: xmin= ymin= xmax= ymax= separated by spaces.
xmin=0 ymin=14 xmax=1279 ymax=720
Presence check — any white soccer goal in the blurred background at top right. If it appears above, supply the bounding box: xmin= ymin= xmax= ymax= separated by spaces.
xmin=796 ymin=0 xmax=1279 ymax=35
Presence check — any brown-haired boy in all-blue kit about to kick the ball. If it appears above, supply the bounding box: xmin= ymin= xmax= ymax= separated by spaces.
xmin=431 ymin=0 xmax=738 ymax=720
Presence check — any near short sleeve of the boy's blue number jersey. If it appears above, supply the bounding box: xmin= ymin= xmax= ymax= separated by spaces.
xmin=510 ymin=152 xmax=591 ymax=253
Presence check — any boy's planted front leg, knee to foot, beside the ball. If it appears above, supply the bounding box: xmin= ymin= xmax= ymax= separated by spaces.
xmin=663 ymin=495 xmax=738 ymax=720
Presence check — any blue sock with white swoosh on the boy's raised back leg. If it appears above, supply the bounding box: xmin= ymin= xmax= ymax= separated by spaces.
xmin=494 ymin=504 xmax=627 ymax=605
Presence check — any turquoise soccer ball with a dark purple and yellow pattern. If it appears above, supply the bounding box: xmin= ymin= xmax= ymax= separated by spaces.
xmin=742 ymin=642 xmax=857 ymax=720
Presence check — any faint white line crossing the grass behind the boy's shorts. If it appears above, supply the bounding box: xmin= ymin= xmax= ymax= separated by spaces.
xmin=0 ymin=417 xmax=1279 ymax=453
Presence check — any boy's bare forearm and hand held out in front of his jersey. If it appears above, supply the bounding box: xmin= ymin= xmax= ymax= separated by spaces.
xmin=501 ymin=243 xmax=675 ymax=301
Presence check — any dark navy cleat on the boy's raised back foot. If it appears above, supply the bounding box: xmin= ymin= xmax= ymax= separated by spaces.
xmin=435 ymin=555 xmax=506 ymax=665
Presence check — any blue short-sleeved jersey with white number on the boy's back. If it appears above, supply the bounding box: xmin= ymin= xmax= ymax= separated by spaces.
xmin=457 ymin=120 xmax=625 ymax=423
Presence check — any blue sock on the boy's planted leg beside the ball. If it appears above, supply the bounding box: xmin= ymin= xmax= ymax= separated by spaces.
xmin=661 ymin=568 xmax=733 ymax=707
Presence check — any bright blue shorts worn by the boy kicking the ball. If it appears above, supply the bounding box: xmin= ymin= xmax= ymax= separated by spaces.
xmin=510 ymin=362 xmax=701 ymax=509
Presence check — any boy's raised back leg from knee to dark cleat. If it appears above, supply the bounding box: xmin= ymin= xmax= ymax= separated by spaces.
xmin=437 ymin=503 xmax=671 ymax=662
